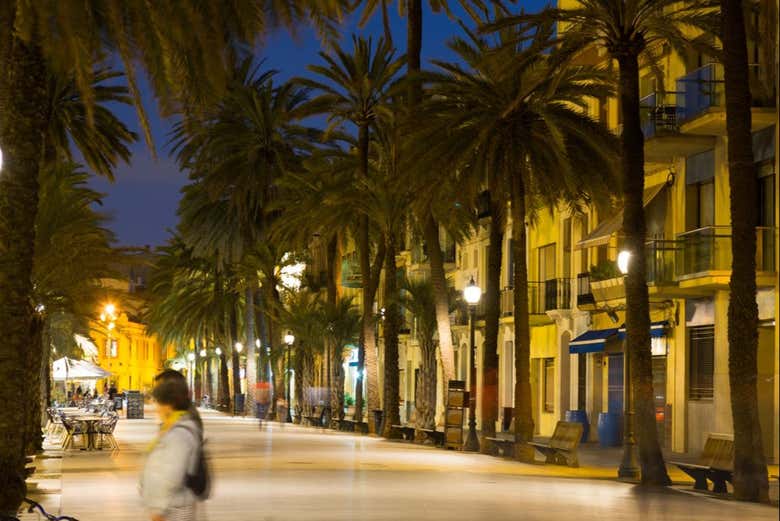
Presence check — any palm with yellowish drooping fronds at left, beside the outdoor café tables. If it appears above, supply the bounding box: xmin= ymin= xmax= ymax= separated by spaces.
xmin=24 ymin=163 xmax=118 ymax=453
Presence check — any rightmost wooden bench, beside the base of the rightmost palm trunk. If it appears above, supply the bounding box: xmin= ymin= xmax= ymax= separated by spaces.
xmin=670 ymin=433 xmax=734 ymax=494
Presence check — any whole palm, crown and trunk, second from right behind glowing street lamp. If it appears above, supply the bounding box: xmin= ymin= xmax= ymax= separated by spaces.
xmin=493 ymin=0 xmax=712 ymax=485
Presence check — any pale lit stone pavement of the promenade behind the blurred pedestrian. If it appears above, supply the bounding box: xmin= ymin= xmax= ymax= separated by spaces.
xmin=35 ymin=413 xmax=778 ymax=521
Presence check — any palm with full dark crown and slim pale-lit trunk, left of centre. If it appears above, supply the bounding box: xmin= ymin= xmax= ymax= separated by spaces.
xmin=173 ymin=57 xmax=319 ymax=414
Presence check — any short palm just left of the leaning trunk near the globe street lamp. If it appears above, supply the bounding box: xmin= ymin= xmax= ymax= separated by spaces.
xmin=401 ymin=279 xmax=436 ymax=430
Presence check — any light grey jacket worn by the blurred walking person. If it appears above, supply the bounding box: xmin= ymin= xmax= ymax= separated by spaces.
xmin=140 ymin=416 xmax=201 ymax=517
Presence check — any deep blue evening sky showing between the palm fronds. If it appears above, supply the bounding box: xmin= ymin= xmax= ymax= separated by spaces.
xmin=92 ymin=0 xmax=544 ymax=246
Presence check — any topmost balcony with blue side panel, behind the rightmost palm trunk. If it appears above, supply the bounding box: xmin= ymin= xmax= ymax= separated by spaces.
xmin=677 ymin=63 xmax=777 ymax=136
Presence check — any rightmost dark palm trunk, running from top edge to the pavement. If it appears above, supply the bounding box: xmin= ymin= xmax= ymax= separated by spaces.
xmin=721 ymin=0 xmax=769 ymax=502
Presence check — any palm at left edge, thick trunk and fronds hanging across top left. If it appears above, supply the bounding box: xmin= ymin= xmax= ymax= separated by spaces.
xmin=0 ymin=0 xmax=346 ymax=508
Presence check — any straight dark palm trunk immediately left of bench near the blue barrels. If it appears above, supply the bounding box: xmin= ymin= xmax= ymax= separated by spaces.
xmin=512 ymin=173 xmax=534 ymax=461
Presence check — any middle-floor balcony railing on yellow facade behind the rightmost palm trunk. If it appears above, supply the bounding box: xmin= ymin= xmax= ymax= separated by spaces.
xmin=675 ymin=226 xmax=777 ymax=278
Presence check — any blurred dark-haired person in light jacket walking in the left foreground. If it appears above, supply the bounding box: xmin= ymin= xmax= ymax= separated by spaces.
xmin=140 ymin=371 xmax=208 ymax=521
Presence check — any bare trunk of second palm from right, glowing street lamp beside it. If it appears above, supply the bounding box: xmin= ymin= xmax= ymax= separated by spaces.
xmin=618 ymin=52 xmax=671 ymax=486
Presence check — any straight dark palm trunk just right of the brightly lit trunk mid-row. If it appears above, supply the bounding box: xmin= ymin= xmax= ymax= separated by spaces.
xmin=382 ymin=231 xmax=401 ymax=438
